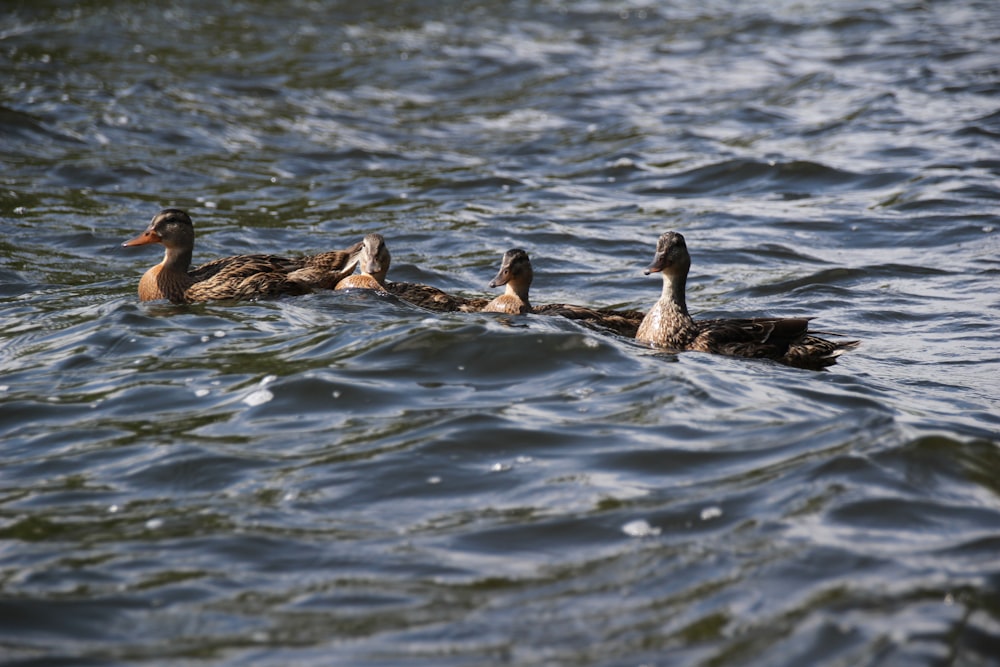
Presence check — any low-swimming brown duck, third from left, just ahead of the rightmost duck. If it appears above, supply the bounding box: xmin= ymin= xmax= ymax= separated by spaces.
xmin=481 ymin=248 xmax=644 ymax=338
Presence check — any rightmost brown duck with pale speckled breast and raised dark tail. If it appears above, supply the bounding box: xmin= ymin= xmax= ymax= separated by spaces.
xmin=635 ymin=231 xmax=860 ymax=370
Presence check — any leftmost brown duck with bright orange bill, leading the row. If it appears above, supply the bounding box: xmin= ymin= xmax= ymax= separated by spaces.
xmin=122 ymin=208 xmax=361 ymax=304
